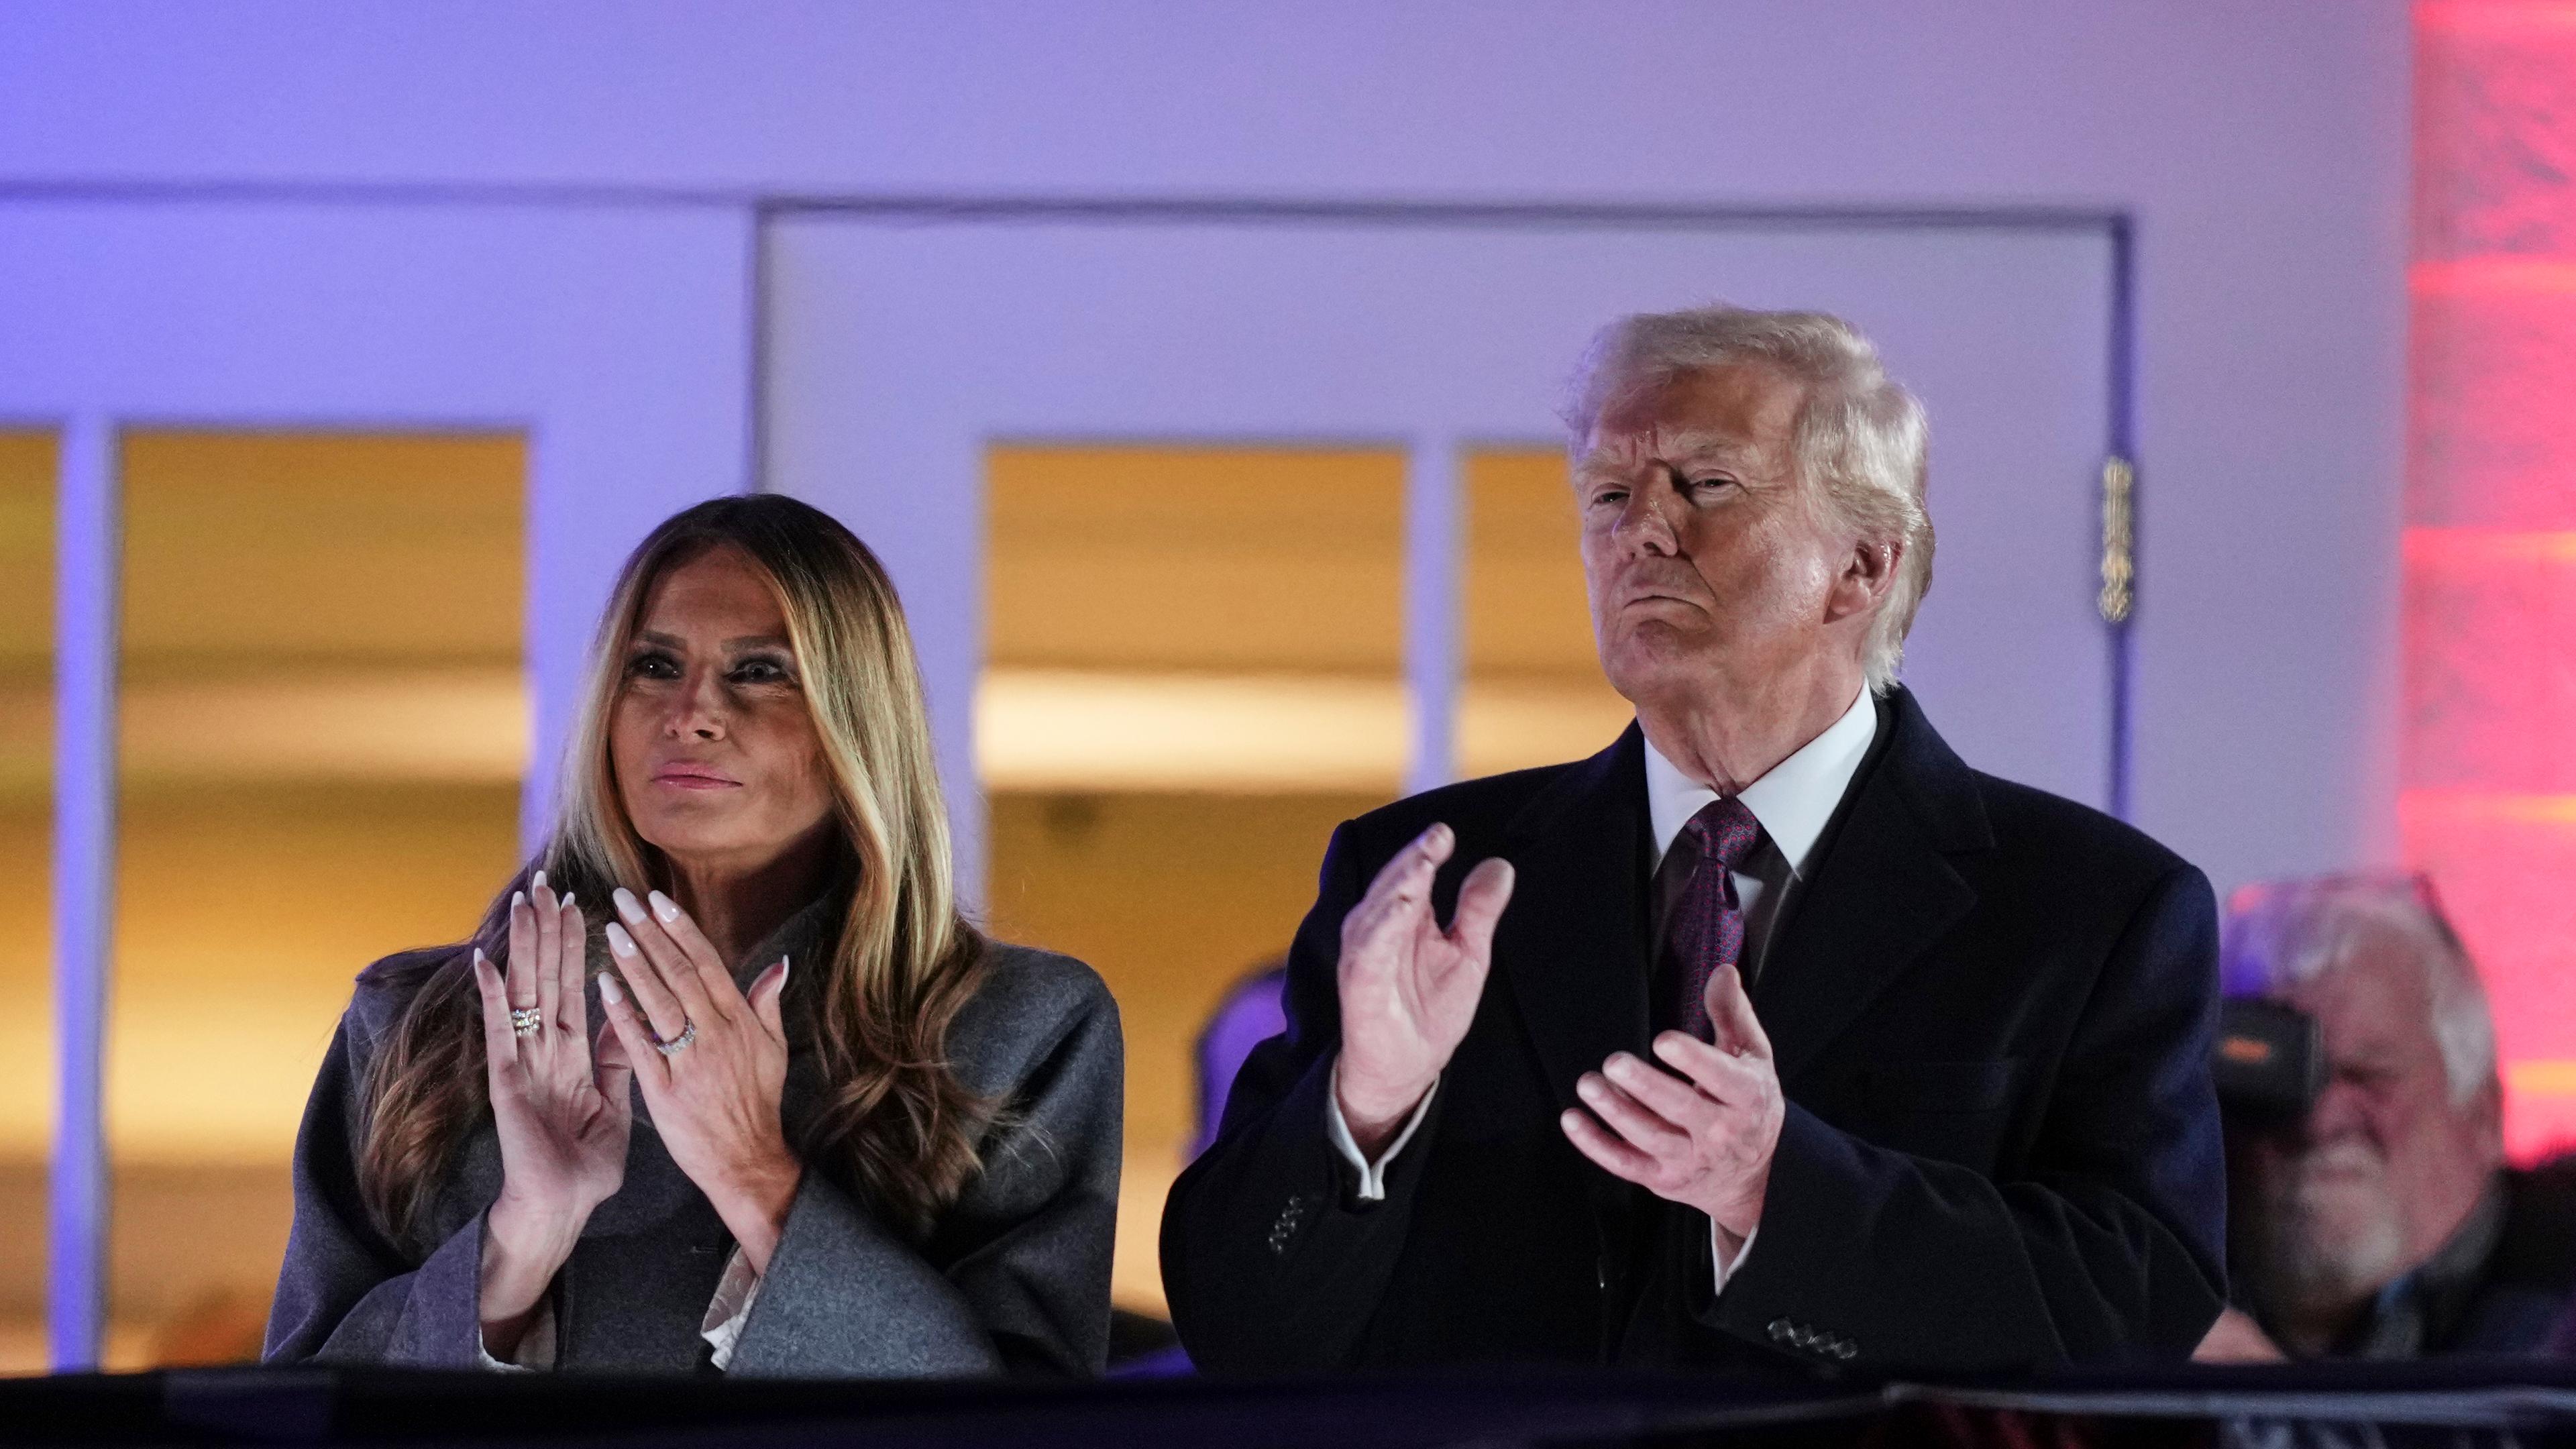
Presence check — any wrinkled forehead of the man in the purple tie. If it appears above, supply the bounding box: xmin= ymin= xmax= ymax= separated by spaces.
xmin=1574 ymin=364 xmax=1806 ymax=474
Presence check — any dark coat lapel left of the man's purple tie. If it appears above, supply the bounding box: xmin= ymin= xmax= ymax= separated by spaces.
xmin=1494 ymin=724 xmax=1646 ymax=1112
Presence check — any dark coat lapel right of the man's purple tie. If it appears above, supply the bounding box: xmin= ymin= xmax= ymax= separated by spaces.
xmin=1752 ymin=688 xmax=1994 ymax=1083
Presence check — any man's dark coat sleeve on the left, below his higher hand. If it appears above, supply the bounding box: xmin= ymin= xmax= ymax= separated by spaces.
xmin=1162 ymin=825 xmax=1442 ymax=1375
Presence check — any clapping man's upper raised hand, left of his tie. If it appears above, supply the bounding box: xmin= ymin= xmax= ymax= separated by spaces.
xmin=1334 ymin=825 xmax=1512 ymax=1155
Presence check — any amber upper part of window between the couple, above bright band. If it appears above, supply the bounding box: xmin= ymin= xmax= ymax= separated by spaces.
xmin=984 ymin=446 xmax=1404 ymax=676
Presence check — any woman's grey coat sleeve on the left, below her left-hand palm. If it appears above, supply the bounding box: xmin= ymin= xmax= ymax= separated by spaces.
xmin=260 ymin=987 xmax=484 ymax=1369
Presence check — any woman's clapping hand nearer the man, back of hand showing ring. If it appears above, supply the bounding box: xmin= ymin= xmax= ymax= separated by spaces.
xmin=600 ymin=890 xmax=804 ymax=1274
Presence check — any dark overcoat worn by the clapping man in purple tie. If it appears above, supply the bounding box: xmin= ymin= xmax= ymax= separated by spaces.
xmin=1162 ymin=688 xmax=2226 ymax=1377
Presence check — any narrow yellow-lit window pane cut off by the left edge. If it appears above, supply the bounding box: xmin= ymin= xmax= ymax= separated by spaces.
xmin=0 ymin=431 xmax=56 ymax=1375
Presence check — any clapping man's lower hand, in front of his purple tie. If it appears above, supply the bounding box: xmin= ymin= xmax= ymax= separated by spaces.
xmin=1561 ymin=967 xmax=1788 ymax=1253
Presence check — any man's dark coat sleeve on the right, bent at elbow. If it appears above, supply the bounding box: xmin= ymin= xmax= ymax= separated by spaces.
xmin=1698 ymin=866 xmax=2226 ymax=1372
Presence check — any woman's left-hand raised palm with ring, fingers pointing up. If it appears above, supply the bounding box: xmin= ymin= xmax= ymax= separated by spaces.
xmin=474 ymin=871 xmax=634 ymax=1354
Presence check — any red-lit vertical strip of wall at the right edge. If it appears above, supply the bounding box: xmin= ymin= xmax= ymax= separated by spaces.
xmin=2398 ymin=0 xmax=2576 ymax=1158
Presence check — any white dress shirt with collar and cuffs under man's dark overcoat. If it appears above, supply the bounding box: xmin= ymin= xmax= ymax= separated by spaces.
xmin=1324 ymin=688 xmax=1878 ymax=1292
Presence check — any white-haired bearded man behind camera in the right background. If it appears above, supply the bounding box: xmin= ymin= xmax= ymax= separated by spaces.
xmin=2198 ymin=874 xmax=2576 ymax=1361
